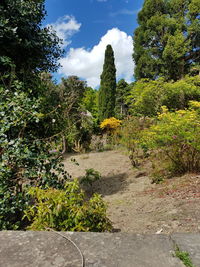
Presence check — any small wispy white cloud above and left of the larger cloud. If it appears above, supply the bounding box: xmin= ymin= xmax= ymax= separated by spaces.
xmin=47 ymin=15 xmax=81 ymax=47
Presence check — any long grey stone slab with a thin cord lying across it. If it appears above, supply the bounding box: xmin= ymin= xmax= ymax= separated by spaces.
xmin=0 ymin=231 xmax=184 ymax=267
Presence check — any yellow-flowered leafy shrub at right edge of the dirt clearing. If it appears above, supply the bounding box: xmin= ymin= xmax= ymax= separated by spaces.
xmin=140 ymin=102 xmax=200 ymax=176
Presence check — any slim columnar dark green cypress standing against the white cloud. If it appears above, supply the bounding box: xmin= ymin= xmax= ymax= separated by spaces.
xmin=99 ymin=45 xmax=116 ymax=121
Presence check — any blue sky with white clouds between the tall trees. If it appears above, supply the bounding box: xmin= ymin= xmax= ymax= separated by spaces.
xmin=44 ymin=0 xmax=143 ymax=88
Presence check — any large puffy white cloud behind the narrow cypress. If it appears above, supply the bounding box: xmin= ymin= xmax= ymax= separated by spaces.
xmin=60 ymin=28 xmax=134 ymax=87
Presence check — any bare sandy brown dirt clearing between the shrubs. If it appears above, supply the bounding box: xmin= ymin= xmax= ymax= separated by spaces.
xmin=64 ymin=151 xmax=200 ymax=233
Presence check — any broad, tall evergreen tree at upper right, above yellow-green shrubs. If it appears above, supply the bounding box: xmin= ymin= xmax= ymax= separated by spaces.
xmin=133 ymin=0 xmax=200 ymax=80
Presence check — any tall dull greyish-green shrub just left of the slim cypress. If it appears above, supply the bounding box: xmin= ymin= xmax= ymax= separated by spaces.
xmin=58 ymin=76 xmax=93 ymax=152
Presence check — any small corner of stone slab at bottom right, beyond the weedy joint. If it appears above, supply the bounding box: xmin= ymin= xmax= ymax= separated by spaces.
xmin=171 ymin=233 xmax=200 ymax=267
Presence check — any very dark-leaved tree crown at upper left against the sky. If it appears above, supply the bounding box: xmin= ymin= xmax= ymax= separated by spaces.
xmin=0 ymin=0 xmax=61 ymax=83
